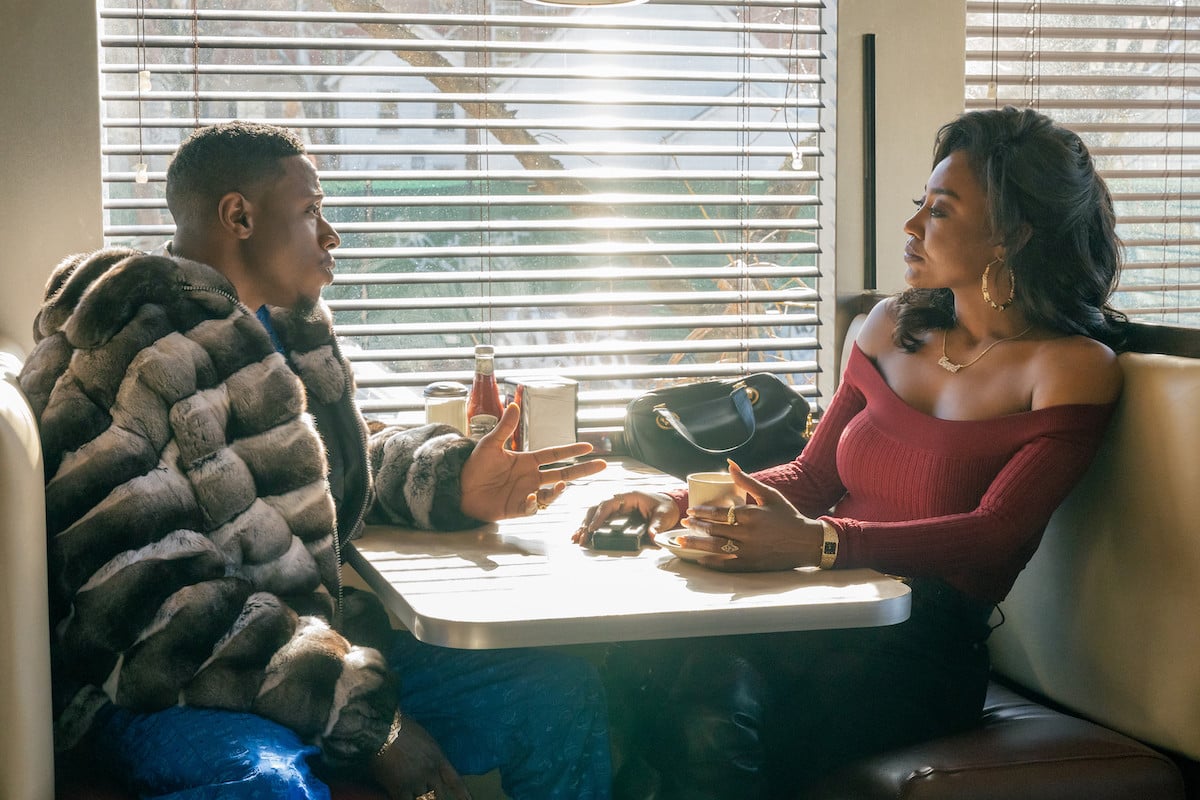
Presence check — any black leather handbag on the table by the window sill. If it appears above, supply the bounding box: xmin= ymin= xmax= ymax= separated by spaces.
xmin=625 ymin=372 xmax=812 ymax=477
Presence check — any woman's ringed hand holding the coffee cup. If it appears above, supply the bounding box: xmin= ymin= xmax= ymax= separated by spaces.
xmin=676 ymin=462 xmax=822 ymax=572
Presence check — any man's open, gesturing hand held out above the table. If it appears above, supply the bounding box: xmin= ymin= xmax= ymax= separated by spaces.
xmin=460 ymin=403 xmax=607 ymax=522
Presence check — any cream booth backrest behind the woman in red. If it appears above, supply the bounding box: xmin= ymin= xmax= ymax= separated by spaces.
xmin=989 ymin=347 xmax=1200 ymax=759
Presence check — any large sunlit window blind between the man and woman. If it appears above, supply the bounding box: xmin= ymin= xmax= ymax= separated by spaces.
xmin=100 ymin=0 xmax=832 ymax=437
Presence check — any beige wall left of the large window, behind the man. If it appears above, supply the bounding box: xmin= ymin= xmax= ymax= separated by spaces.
xmin=0 ymin=0 xmax=102 ymax=350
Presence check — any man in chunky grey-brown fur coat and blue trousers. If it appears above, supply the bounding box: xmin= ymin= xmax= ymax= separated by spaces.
xmin=22 ymin=122 xmax=610 ymax=800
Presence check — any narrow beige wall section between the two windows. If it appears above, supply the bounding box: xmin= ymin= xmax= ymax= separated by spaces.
xmin=822 ymin=0 xmax=966 ymax=376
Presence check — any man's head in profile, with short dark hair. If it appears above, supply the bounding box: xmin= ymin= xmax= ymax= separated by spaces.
xmin=167 ymin=122 xmax=340 ymax=308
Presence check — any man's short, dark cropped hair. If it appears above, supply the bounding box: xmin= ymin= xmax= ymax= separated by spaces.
xmin=167 ymin=121 xmax=305 ymax=224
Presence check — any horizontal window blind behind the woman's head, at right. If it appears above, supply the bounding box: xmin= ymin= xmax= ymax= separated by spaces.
xmin=966 ymin=0 xmax=1200 ymax=327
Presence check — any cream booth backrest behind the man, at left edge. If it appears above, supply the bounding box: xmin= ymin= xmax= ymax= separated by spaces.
xmin=0 ymin=337 xmax=54 ymax=800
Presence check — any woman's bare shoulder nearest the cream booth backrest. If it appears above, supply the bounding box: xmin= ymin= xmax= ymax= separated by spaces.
xmin=1032 ymin=336 xmax=1123 ymax=408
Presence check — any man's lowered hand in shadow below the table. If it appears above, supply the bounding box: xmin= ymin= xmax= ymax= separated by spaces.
xmin=371 ymin=717 xmax=470 ymax=800
